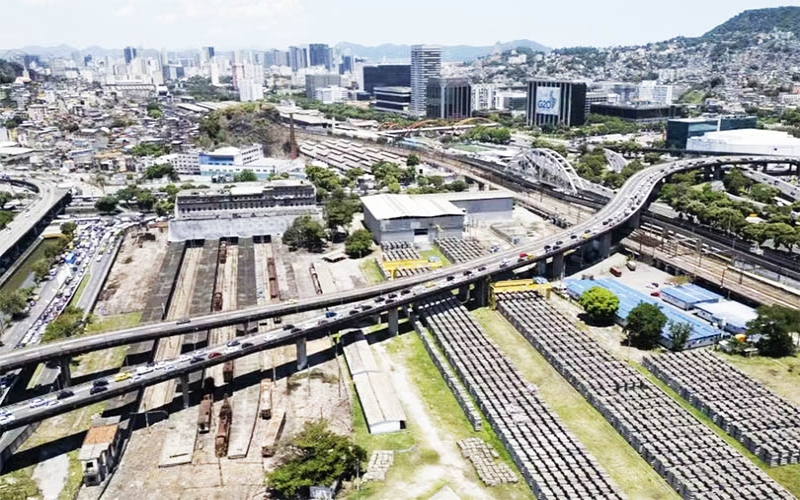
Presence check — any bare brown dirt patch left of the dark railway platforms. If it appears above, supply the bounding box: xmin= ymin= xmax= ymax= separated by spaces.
xmin=95 ymin=229 xmax=167 ymax=316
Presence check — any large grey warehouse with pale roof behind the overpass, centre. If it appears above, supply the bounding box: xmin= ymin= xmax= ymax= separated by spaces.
xmin=361 ymin=191 xmax=514 ymax=243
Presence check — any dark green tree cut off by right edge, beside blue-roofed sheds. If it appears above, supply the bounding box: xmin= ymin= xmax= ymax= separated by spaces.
xmin=747 ymin=305 xmax=800 ymax=358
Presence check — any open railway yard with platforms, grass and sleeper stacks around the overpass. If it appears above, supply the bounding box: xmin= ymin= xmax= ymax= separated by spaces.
xmin=0 ymin=156 xmax=800 ymax=500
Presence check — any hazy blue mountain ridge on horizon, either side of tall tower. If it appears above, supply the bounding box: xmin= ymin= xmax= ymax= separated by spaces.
xmin=336 ymin=40 xmax=550 ymax=62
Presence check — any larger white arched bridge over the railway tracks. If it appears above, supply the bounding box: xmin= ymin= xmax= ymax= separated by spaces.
xmin=506 ymin=148 xmax=586 ymax=194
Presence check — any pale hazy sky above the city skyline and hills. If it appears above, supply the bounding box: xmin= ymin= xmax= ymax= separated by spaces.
xmin=0 ymin=0 xmax=800 ymax=50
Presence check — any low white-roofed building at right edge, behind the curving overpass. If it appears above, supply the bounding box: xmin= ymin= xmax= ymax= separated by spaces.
xmin=686 ymin=129 xmax=800 ymax=156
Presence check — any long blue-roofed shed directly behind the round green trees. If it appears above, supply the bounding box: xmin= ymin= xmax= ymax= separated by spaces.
xmin=566 ymin=278 xmax=721 ymax=348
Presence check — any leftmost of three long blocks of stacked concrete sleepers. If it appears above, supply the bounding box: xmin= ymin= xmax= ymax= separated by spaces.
xmin=420 ymin=294 xmax=622 ymax=500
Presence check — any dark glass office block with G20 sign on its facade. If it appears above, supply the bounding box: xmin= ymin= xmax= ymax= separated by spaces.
xmin=527 ymin=80 xmax=586 ymax=127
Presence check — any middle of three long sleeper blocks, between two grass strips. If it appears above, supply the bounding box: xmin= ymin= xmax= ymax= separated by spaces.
xmin=498 ymin=292 xmax=794 ymax=499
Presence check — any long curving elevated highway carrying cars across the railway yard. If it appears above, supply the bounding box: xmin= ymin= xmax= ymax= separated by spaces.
xmin=0 ymin=153 xmax=795 ymax=430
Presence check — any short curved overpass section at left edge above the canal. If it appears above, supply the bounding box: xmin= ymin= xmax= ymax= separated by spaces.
xmin=0 ymin=176 xmax=70 ymax=272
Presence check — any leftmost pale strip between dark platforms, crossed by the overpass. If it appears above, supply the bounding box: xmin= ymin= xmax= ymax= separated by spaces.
xmin=140 ymin=247 xmax=203 ymax=411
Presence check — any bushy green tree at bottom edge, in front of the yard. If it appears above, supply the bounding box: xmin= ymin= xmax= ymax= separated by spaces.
xmin=267 ymin=420 xmax=367 ymax=498
